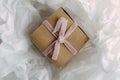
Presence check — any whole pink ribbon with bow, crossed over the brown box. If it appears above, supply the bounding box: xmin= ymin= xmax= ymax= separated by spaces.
xmin=43 ymin=17 xmax=77 ymax=60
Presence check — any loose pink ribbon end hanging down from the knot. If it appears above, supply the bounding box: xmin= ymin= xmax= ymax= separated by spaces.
xmin=52 ymin=41 xmax=60 ymax=60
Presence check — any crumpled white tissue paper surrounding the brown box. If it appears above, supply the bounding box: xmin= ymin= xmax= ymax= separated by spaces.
xmin=0 ymin=0 xmax=120 ymax=80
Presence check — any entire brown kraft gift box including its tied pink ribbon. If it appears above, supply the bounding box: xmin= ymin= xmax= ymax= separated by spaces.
xmin=30 ymin=8 xmax=89 ymax=68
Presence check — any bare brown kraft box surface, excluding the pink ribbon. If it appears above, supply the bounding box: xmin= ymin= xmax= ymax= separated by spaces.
xmin=30 ymin=8 xmax=89 ymax=68
